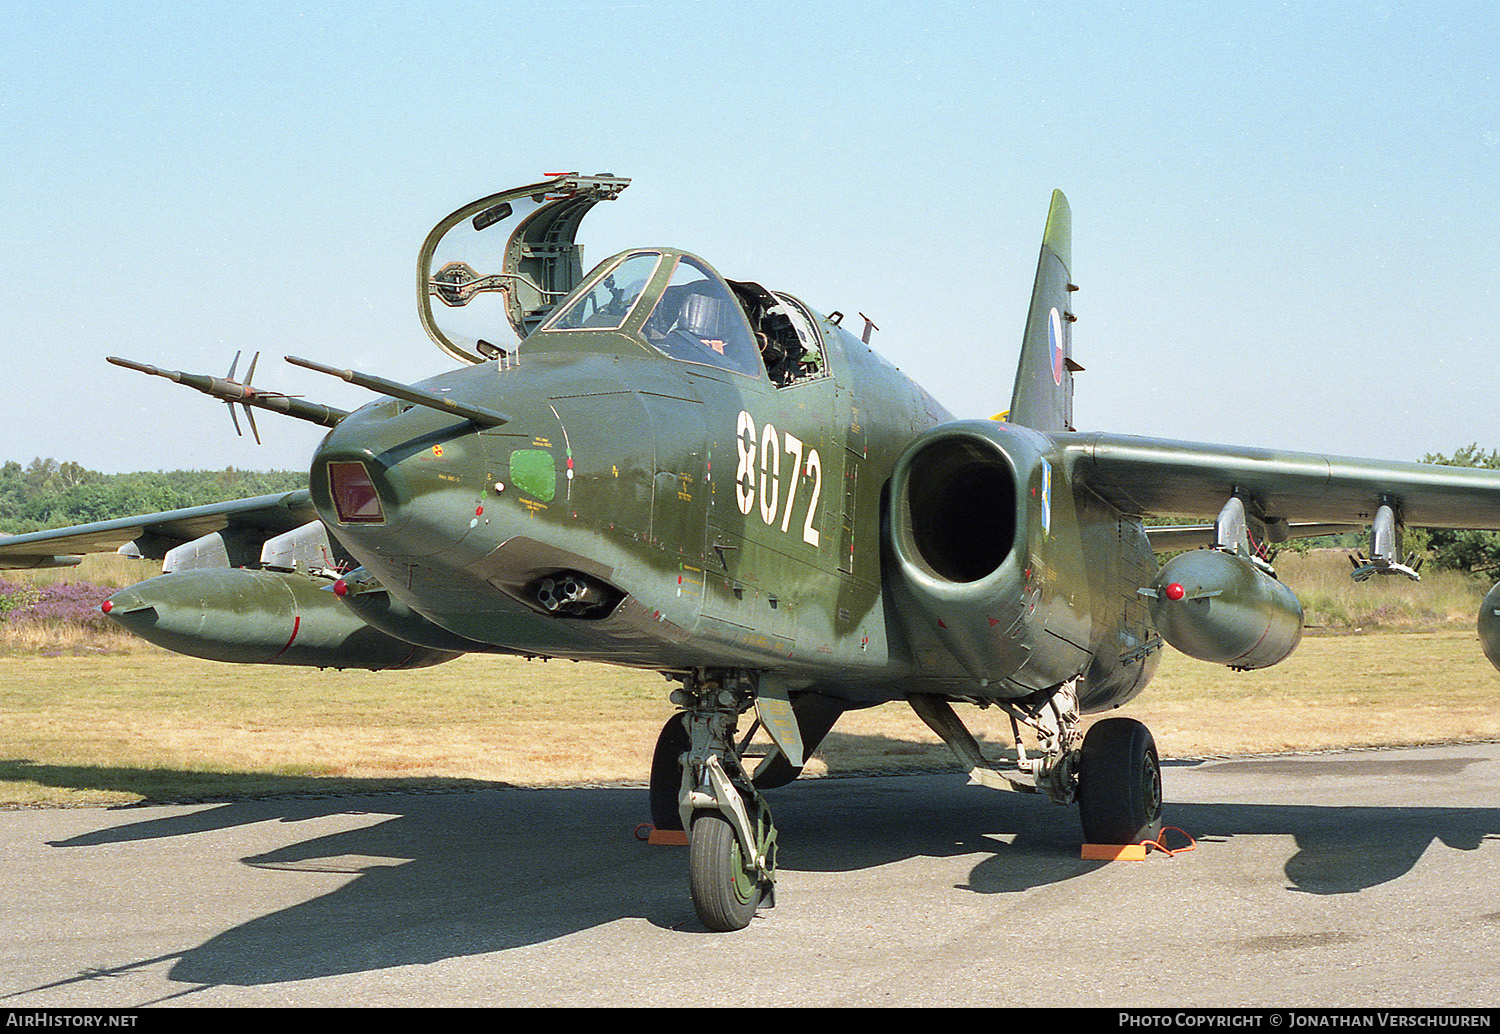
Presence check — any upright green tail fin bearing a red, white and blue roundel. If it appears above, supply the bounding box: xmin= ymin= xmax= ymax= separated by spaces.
xmin=1010 ymin=191 xmax=1083 ymax=431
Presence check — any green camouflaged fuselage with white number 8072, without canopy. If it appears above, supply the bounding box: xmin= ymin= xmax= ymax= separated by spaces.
xmin=311 ymin=253 xmax=1160 ymax=708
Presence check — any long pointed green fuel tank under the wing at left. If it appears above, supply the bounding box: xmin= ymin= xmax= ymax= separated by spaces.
xmin=101 ymin=567 xmax=459 ymax=671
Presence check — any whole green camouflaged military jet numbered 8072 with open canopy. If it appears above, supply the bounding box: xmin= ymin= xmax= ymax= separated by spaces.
xmin=0 ymin=174 xmax=1500 ymax=930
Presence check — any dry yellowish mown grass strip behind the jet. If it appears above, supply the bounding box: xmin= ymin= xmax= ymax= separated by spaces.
xmin=0 ymin=630 xmax=1500 ymax=806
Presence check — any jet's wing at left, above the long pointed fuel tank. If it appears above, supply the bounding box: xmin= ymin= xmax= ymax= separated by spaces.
xmin=0 ymin=489 xmax=318 ymax=569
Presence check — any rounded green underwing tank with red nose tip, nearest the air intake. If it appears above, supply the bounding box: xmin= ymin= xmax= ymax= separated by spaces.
xmin=1146 ymin=549 xmax=1302 ymax=671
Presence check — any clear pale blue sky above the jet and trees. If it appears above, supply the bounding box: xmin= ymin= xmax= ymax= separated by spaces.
xmin=0 ymin=0 xmax=1500 ymax=471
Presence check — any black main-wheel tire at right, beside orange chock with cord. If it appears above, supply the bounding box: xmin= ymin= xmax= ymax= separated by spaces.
xmin=1079 ymin=717 xmax=1161 ymax=843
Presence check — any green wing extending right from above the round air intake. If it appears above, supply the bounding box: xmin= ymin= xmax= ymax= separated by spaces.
xmin=1055 ymin=432 xmax=1500 ymax=534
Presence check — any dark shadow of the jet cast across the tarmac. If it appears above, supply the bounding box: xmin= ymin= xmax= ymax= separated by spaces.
xmin=20 ymin=758 xmax=1500 ymax=993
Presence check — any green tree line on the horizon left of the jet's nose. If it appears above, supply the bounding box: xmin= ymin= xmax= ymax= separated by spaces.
xmin=0 ymin=458 xmax=308 ymax=534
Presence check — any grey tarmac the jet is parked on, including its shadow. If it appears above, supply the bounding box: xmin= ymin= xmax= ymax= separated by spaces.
xmin=0 ymin=744 xmax=1500 ymax=1010
